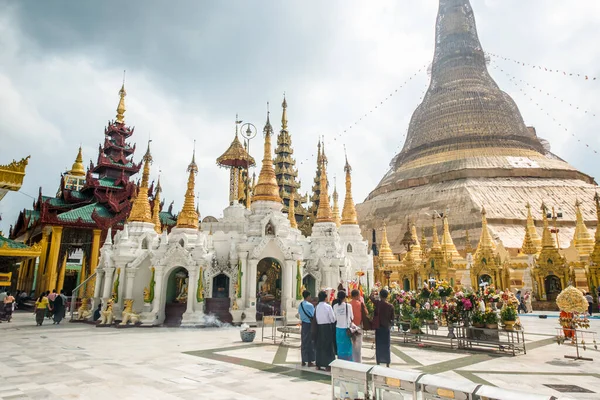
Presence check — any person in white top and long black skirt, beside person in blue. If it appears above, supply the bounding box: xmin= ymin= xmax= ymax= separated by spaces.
xmin=313 ymin=291 xmax=335 ymax=371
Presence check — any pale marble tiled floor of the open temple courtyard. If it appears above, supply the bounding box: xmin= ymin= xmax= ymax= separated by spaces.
xmin=0 ymin=312 xmax=600 ymax=400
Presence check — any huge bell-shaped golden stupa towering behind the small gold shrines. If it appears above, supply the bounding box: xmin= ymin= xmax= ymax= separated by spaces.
xmin=356 ymin=0 xmax=597 ymax=251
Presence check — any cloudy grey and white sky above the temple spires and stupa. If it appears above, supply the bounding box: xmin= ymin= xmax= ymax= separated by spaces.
xmin=0 ymin=0 xmax=600 ymax=232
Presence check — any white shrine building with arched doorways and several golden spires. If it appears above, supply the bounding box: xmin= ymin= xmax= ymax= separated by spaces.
xmin=92 ymin=112 xmax=373 ymax=326
